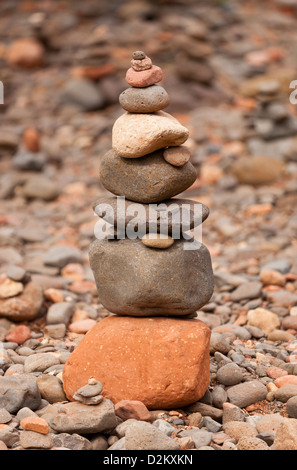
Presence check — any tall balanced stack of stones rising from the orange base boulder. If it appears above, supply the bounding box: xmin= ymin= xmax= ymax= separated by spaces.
xmin=63 ymin=51 xmax=213 ymax=409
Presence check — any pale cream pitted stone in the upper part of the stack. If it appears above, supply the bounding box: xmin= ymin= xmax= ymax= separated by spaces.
xmin=112 ymin=111 xmax=189 ymax=158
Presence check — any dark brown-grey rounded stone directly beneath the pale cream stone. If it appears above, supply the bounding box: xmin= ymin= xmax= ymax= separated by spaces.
xmin=99 ymin=150 xmax=197 ymax=204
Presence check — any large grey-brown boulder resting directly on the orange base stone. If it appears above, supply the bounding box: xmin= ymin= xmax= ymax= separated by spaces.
xmin=89 ymin=238 xmax=214 ymax=316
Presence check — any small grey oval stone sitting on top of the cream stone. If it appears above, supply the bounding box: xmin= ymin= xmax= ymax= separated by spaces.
xmin=119 ymin=85 xmax=169 ymax=113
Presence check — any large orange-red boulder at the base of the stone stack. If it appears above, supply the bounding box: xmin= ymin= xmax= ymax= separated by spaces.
xmin=63 ymin=316 xmax=210 ymax=409
